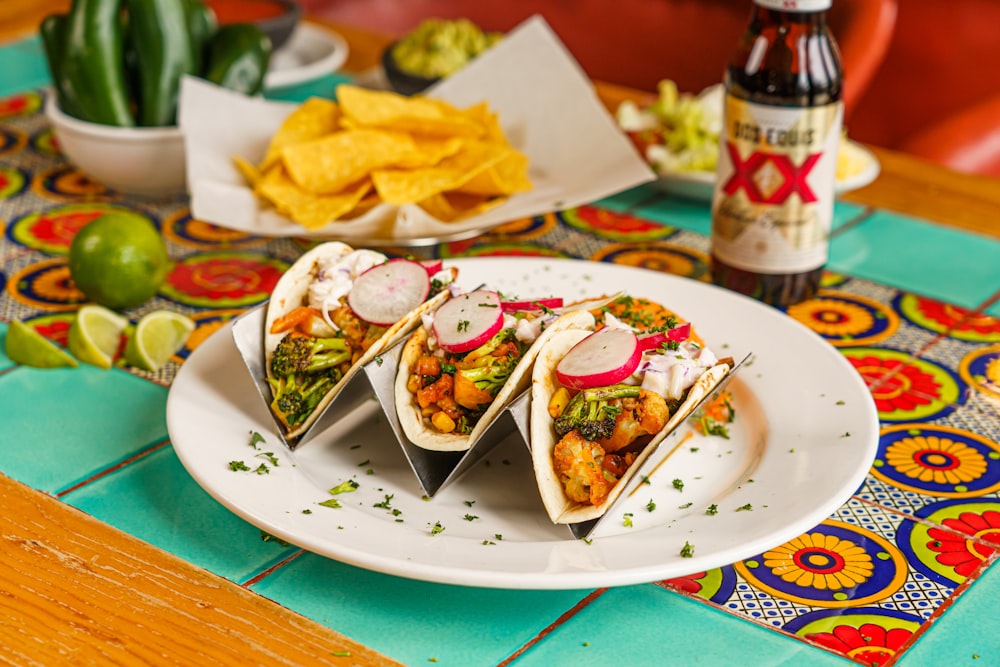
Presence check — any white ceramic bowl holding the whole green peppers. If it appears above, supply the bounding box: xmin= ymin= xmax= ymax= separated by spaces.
xmin=45 ymin=95 xmax=186 ymax=197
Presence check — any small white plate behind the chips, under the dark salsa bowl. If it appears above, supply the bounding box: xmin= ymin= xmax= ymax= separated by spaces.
xmin=264 ymin=21 xmax=348 ymax=90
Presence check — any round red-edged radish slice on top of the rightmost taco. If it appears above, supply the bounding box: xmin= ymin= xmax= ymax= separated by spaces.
xmin=556 ymin=327 xmax=642 ymax=389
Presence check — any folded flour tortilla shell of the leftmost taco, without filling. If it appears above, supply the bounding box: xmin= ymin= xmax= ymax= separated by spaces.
xmin=264 ymin=241 xmax=457 ymax=440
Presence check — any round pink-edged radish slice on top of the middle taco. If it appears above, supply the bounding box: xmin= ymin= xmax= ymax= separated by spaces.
xmin=434 ymin=290 xmax=503 ymax=354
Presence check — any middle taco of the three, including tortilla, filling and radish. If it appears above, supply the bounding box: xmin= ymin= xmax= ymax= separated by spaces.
xmin=395 ymin=289 xmax=608 ymax=451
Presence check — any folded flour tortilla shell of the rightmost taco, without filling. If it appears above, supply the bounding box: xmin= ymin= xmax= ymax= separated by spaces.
xmin=530 ymin=331 xmax=730 ymax=523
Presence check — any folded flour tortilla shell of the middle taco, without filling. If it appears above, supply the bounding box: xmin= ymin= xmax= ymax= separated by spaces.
xmin=395 ymin=302 xmax=594 ymax=452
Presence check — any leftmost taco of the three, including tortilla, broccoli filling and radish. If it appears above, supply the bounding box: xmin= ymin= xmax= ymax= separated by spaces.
xmin=264 ymin=242 xmax=457 ymax=440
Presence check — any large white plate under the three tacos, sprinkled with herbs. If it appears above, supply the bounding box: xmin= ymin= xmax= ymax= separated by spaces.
xmin=167 ymin=258 xmax=879 ymax=589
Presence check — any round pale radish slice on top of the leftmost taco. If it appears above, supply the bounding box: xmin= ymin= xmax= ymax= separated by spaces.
xmin=347 ymin=258 xmax=431 ymax=327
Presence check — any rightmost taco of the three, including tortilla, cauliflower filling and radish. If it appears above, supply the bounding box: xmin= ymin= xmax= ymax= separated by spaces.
xmin=530 ymin=300 xmax=733 ymax=524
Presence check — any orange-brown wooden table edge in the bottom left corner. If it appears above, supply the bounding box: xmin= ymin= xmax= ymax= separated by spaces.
xmin=0 ymin=474 xmax=401 ymax=667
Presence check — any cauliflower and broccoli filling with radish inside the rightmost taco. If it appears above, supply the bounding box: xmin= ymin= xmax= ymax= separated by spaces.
xmin=547 ymin=297 xmax=728 ymax=507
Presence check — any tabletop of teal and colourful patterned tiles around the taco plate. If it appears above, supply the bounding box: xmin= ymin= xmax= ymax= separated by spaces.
xmin=0 ymin=35 xmax=1000 ymax=667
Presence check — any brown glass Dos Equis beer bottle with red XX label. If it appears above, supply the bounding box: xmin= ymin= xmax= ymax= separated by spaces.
xmin=712 ymin=0 xmax=843 ymax=307
